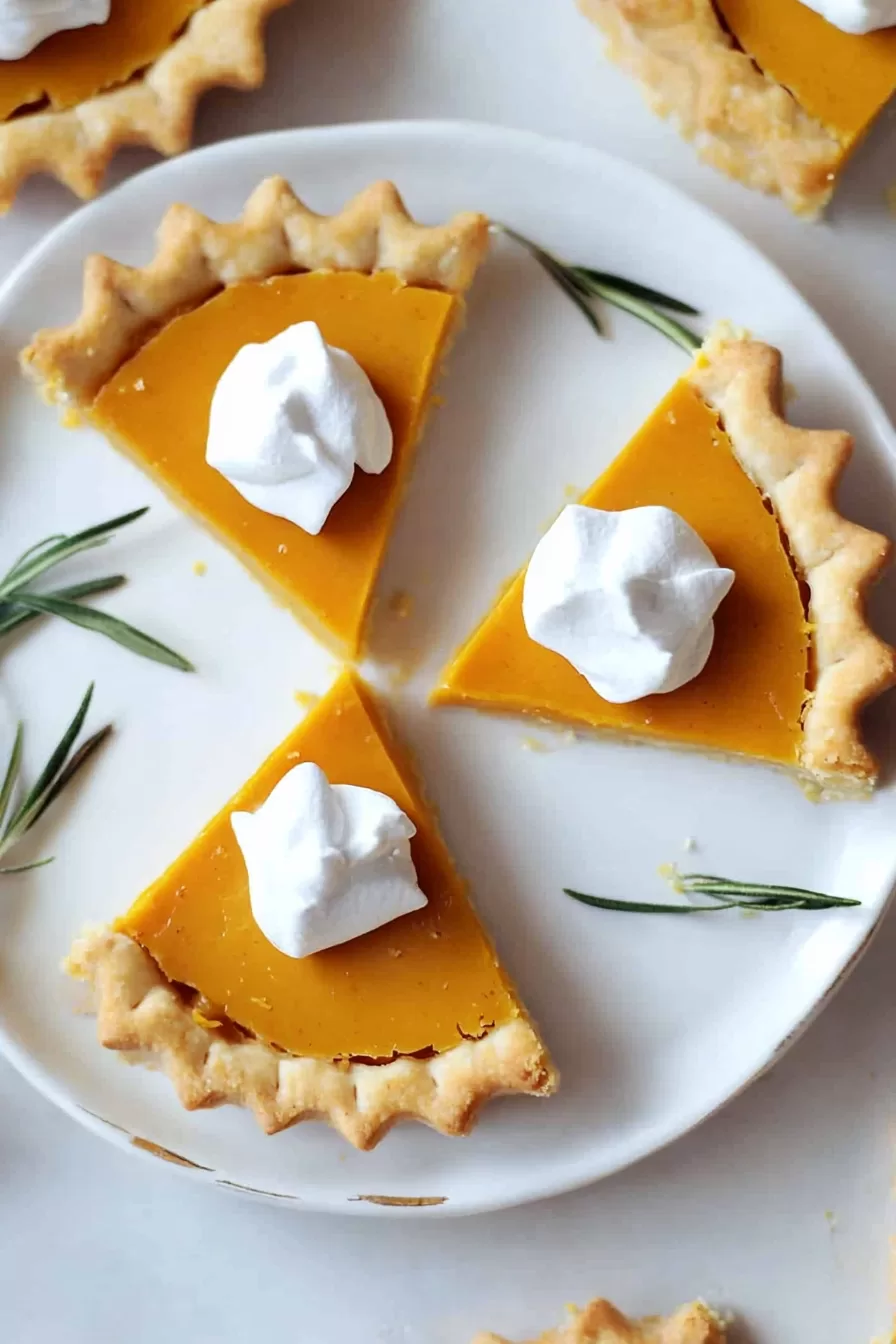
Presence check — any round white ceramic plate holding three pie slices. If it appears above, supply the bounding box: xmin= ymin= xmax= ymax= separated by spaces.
xmin=0 ymin=124 xmax=896 ymax=1215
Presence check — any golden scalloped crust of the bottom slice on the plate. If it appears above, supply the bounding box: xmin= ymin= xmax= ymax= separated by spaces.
xmin=66 ymin=929 xmax=557 ymax=1149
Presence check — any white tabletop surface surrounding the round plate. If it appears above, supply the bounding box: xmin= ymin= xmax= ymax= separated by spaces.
xmin=0 ymin=0 xmax=896 ymax=1344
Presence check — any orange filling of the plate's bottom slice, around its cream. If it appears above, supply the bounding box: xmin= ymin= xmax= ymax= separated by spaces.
xmin=116 ymin=673 xmax=524 ymax=1063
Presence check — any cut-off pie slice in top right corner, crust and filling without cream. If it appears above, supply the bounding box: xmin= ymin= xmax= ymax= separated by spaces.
xmin=579 ymin=0 xmax=896 ymax=216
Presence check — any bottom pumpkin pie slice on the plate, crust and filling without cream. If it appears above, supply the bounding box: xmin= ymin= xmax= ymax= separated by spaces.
xmin=69 ymin=672 xmax=556 ymax=1148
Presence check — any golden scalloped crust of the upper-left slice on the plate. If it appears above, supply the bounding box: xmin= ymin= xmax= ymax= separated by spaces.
xmin=20 ymin=177 xmax=489 ymax=405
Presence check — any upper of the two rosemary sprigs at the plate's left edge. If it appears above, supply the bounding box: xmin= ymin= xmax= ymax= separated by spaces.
xmin=0 ymin=508 xmax=195 ymax=672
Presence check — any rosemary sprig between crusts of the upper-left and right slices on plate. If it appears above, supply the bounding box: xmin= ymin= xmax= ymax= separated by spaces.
xmin=492 ymin=220 xmax=703 ymax=355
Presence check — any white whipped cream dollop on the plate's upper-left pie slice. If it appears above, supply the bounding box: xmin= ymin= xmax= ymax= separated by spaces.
xmin=206 ymin=323 xmax=392 ymax=536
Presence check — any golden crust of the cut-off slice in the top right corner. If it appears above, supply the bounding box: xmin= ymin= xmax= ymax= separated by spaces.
xmin=579 ymin=0 xmax=844 ymax=216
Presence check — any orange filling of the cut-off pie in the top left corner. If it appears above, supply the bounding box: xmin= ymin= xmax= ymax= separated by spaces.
xmin=0 ymin=0 xmax=207 ymax=121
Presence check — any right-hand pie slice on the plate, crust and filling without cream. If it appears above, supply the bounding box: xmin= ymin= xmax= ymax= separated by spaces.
xmin=431 ymin=328 xmax=896 ymax=798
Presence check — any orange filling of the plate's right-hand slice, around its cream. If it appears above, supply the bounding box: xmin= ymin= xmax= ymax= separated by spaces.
xmin=431 ymin=379 xmax=810 ymax=767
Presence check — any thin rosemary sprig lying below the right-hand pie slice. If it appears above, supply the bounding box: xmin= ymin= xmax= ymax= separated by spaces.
xmin=563 ymin=864 xmax=861 ymax=915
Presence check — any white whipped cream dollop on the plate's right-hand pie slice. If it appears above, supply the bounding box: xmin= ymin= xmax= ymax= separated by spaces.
xmin=523 ymin=504 xmax=735 ymax=704
